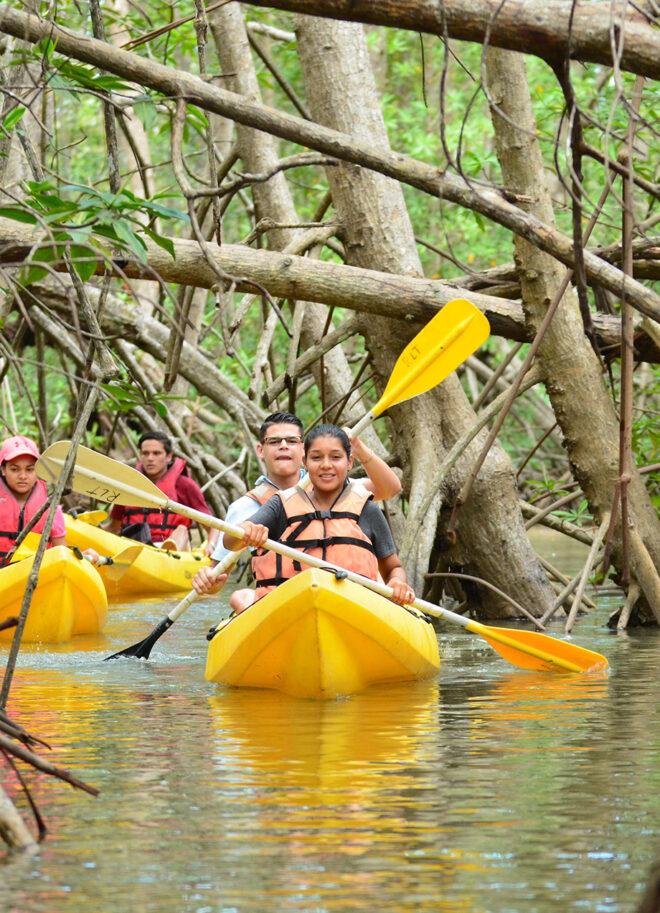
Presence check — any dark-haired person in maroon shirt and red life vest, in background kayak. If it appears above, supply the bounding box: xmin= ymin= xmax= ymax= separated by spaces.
xmin=108 ymin=431 xmax=218 ymax=555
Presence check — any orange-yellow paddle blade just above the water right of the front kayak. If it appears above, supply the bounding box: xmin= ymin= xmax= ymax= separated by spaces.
xmin=465 ymin=621 xmax=608 ymax=672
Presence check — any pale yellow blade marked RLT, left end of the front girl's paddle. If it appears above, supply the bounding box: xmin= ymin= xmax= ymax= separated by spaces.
xmin=37 ymin=441 xmax=167 ymax=507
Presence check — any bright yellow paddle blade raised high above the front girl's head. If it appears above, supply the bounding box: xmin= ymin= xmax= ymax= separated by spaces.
xmin=371 ymin=298 xmax=490 ymax=416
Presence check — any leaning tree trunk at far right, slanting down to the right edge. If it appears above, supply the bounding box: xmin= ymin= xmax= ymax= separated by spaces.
xmin=486 ymin=48 xmax=660 ymax=610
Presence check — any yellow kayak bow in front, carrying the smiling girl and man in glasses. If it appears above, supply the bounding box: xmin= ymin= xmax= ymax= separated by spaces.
xmin=206 ymin=568 xmax=440 ymax=700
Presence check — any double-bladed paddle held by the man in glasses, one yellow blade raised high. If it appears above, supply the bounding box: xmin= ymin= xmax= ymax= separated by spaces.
xmin=68 ymin=298 xmax=490 ymax=659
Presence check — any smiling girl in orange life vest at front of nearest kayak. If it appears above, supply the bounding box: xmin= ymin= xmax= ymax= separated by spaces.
xmin=224 ymin=425 xmax=415 ymax=612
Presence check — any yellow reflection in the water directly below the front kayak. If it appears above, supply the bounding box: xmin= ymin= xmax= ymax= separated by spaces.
xmin=209 ymin=682 xmax=480 ymax=910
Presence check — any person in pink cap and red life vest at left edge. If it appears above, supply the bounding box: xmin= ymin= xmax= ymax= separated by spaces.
xmin=0 ymin=434 xmax=99 ymax=566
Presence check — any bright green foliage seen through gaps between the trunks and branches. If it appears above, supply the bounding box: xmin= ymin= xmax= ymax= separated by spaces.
xmin=0 ymin=0 xmax=660 ymax=523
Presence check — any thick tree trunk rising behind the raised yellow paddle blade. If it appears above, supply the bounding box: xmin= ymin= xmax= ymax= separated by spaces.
xmin=295 ymin=16 xmax=553 ymax=617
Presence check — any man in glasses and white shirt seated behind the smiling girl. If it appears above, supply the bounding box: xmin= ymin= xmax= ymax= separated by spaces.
xmin=192 ymin=413 xmax=401 ymax=611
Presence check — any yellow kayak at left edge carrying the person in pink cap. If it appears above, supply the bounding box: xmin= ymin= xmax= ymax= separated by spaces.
xmin=0 ymin=545 xmax=108 ymax=644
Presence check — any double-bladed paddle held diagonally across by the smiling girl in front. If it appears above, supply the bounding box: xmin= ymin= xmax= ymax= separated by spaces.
xmin=37 ymin=441 xmax=608 ymax=672
